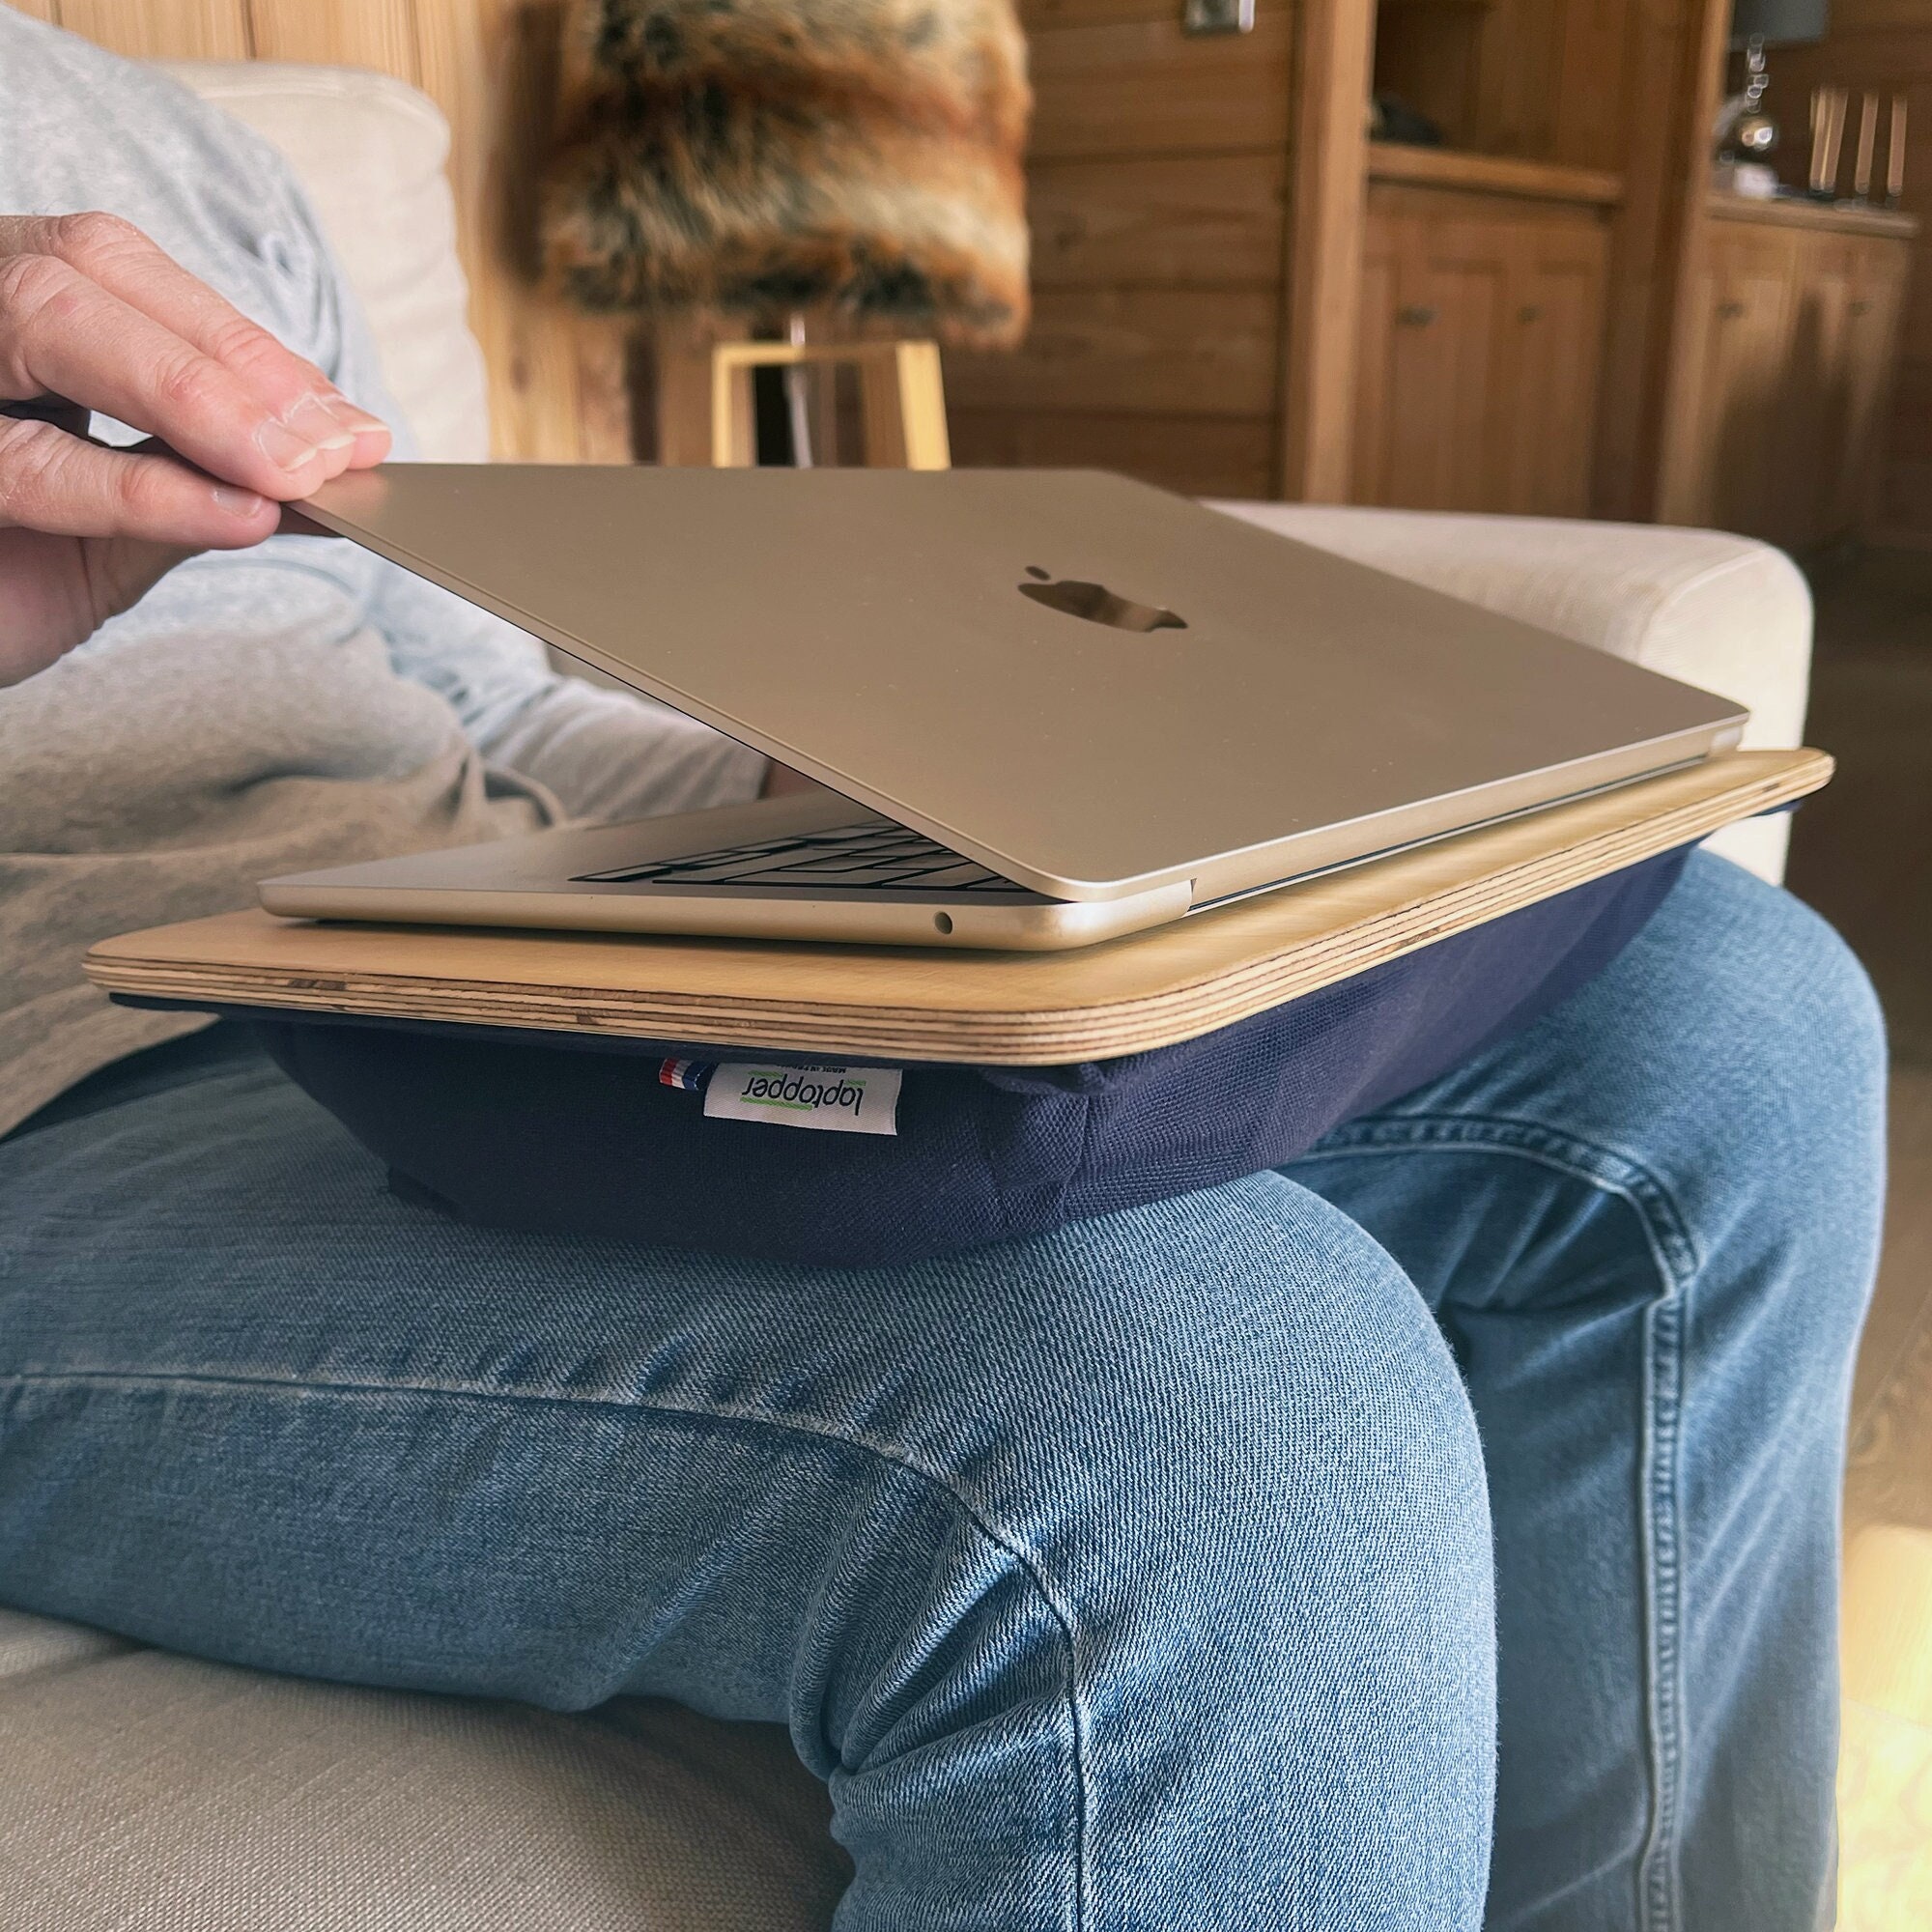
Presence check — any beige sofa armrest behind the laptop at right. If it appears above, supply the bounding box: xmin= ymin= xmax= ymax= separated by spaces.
xmin=1213 ymin=502 xmax=1812 ymax=883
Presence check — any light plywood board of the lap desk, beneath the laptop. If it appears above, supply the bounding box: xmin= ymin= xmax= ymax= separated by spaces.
xmin=87 ymin=752 xmax=1832 ymax=1066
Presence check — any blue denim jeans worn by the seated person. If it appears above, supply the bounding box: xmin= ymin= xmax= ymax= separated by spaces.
xmin=0 ymin=856 xmax=1882 ymax=1932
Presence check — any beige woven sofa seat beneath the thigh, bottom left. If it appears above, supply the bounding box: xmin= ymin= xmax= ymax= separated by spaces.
xmin=0 ymin=1611 xmax=846 ymax=1932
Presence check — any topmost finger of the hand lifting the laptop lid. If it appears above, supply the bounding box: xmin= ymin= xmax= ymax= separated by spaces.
xmin=16 ymin=214 xmax=390 ymax=468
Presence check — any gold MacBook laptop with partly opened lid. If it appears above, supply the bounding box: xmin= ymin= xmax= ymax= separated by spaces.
xmin=261 ymin=464 xmax=1745 ymax=949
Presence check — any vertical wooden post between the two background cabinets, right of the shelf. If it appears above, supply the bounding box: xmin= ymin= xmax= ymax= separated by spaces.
xmin=1592 ymin=0 xmax=1731 ymax=522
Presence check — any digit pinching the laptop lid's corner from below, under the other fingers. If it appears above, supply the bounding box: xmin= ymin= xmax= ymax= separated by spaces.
xmin=0 ymin=412 xmax=280 ymax=551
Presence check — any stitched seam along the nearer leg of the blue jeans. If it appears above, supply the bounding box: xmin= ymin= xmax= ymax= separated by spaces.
xmin=0 ymin=1370 xmax=1092 ymax=1932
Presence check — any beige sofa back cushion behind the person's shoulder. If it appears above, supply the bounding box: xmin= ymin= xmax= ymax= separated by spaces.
xmin=162 ymin=60 xmax=489 ymax=464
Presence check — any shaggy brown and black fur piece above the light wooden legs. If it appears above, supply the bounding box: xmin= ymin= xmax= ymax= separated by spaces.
xmin=543 ymin=0 xmax=1032 ymax=346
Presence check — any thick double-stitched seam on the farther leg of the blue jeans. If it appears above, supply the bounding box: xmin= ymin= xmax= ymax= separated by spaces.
xmin=1293 ymin=1115 xmax=1698 ymax=1932
